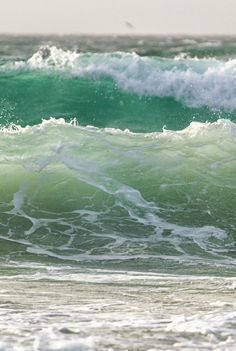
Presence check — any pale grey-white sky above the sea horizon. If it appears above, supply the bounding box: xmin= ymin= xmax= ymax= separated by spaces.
xmin=0 ymin=0 xmax=236 ymax=34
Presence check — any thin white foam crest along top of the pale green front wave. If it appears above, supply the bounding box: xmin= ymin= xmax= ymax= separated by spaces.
xmin=0 ymin=117 xmax=236 ymax=151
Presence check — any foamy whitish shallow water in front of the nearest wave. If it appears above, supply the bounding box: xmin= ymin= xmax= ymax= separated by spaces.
xmin=0 ymin=276 xmax=236 ymax=351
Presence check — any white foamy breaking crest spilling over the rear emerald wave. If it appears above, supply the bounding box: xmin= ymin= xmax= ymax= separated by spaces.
xmin=7 ymin=46 xmax=236 ymax=111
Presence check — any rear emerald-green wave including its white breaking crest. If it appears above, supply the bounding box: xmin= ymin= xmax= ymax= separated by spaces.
xmin=0 ymin=46 xmax=236 ymax=132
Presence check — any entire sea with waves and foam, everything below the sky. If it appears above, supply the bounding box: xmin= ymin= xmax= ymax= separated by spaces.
xmin=0 ymin=36 xmax=236 ymax=351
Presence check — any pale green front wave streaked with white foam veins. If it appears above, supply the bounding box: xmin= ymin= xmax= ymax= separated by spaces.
xmin=0 ymin=119 xmax=236 ymax=269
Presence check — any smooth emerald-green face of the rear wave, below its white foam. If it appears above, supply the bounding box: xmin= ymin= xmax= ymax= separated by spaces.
xmin=0 ymin=71 xmax=230 ymax=132
